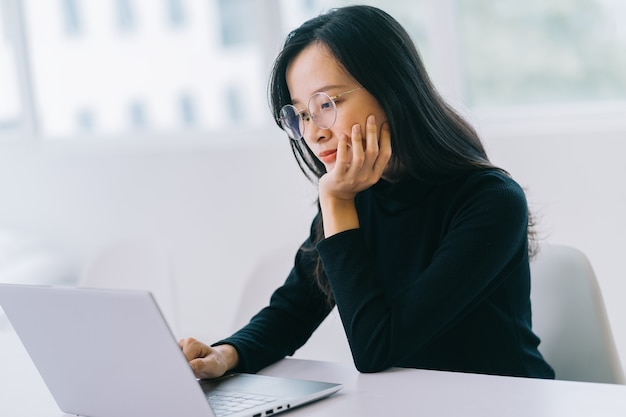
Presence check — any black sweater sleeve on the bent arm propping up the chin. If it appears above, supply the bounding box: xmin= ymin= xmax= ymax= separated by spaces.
xmin=317 ymin=171 xmax=528 ymax=372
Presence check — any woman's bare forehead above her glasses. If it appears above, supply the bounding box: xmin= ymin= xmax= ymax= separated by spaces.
xmin=285 ymin=43 xmax=351 ymax=102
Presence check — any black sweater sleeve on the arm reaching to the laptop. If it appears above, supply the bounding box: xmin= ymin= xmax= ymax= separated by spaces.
xmin=214 ymin=219 xmax=334 ymax=372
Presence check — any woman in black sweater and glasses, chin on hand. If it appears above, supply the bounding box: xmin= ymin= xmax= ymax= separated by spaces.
xmin=180 ymin=6 xmax=554 ymax=378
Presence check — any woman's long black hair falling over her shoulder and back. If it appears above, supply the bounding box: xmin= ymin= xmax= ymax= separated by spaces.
xmin=269 ymin=6 xmax=532 ymax=295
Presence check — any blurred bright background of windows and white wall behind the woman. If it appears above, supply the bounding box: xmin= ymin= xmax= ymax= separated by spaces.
xmin=0 ymin=0 xmax=626 ymax=370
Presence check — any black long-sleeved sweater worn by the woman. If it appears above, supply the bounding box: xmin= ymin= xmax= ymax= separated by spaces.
xmin=217 ymin=170 xmax=554 ymax=378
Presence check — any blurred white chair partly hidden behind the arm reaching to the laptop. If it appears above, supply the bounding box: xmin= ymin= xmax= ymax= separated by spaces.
xmin=232 ymin=245 xmax=352 ymax=362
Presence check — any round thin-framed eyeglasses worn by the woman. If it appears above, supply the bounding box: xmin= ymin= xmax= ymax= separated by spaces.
xmin=278 ymin=87 xmax=363 ymax=140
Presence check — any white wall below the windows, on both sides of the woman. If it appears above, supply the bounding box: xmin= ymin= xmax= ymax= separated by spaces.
xmin=0 ymin=125 xmax=626 ymax=372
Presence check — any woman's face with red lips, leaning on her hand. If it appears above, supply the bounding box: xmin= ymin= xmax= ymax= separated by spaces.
xmin=286 ymin=43 xmax=387 ymax=171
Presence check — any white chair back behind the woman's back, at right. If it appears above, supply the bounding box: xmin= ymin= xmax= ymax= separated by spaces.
xmin=531 ymin=245 xmax=624 ymax=384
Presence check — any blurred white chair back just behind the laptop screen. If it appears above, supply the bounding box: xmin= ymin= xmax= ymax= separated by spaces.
xmin=78 ymin=239 xmax=178 ymax=334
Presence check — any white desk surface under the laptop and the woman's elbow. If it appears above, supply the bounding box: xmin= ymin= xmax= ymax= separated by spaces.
xmin=0 ymin=318 xmax=626 ymax=417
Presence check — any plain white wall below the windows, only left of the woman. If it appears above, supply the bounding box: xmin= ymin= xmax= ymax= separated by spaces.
xmin=0 ymin=135 xmax=315 ymax=338
